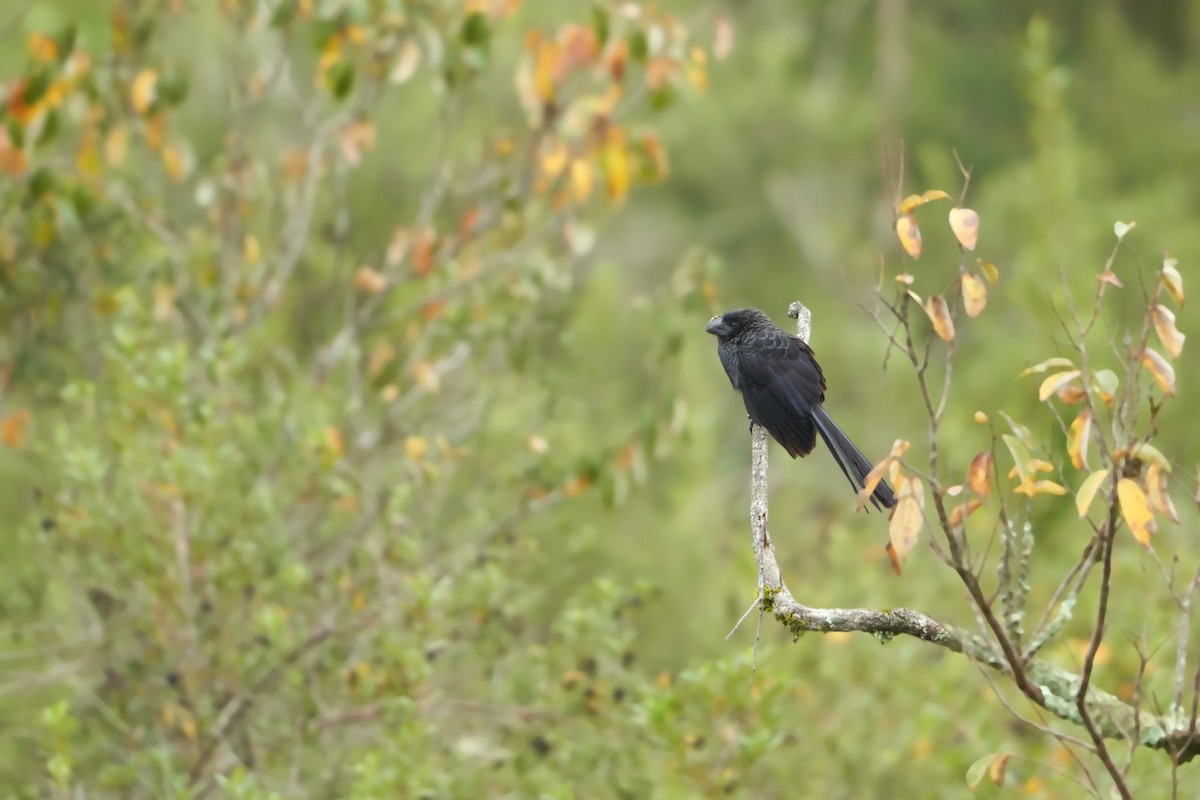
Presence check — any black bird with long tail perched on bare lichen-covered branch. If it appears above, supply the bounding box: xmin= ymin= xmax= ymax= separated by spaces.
xmin=704 ymin=308 xmax=896 ymax=509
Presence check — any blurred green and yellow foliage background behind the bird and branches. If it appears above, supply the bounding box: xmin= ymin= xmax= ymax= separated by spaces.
xmin=0 ymin=0 xmax=1200 ymax=798
